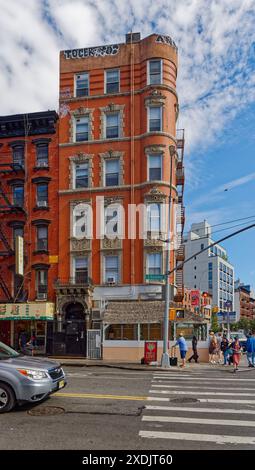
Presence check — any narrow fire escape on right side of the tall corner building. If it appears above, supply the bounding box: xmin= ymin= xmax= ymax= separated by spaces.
xmin=174 ymin=129 xmax=185 ymax=303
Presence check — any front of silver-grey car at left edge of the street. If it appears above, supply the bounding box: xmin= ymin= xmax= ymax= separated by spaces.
xmin=0 ymin=342 xmax=66 ymax=413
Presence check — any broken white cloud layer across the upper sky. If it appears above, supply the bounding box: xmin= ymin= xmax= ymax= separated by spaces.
xmin=0 ymin=0 xmax=255 ymax=151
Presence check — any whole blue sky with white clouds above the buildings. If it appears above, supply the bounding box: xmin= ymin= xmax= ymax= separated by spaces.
xmin=0 ymin=0 xmax=255 ymax=287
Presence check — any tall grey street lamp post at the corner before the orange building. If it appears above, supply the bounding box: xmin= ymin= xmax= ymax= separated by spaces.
xmin=161 ymin=145 xmax=176 ymax=368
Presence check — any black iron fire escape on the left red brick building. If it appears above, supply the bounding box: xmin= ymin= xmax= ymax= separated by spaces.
xmin=0 ymin=146 xmax=25 ymax=302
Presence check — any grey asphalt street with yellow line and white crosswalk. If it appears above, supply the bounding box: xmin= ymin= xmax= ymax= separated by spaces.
xmin=0 ymin=367 xmax=255 ymax=450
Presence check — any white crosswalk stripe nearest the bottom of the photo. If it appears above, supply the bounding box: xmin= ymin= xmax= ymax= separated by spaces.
xmin=139 ymin=431 xmax=255 ymax=444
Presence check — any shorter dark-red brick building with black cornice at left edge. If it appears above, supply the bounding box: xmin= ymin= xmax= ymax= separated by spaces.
xmin=0 ymin=111 xmax=59 ymax=353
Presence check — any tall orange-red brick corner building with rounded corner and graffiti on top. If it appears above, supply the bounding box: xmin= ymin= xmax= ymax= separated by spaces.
xmin=53 ymin=33 xmax=184 ymax=360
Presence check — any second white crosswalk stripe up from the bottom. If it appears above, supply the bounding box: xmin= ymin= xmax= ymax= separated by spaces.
xmin=142 ymin=416 xmax=255 ymax=428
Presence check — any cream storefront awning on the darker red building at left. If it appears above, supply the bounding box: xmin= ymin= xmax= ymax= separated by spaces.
xmin=0 ymin=302 xmax=55 ymax=320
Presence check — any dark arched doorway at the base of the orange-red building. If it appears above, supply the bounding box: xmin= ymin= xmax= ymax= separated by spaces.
xmin=65 ymin=302 xmax=86 ymax=356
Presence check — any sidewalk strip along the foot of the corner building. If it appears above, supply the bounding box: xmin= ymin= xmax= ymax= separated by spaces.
xmin=48 ymin=356 xmax=255 ymax=373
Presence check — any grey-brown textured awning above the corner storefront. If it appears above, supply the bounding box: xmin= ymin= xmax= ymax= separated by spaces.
xmin=103 ymin=300 xmax=165 ymax=324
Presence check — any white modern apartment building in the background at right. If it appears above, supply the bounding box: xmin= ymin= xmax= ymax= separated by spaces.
xmin=184 ymin=221 xmax=235 ymax=311
